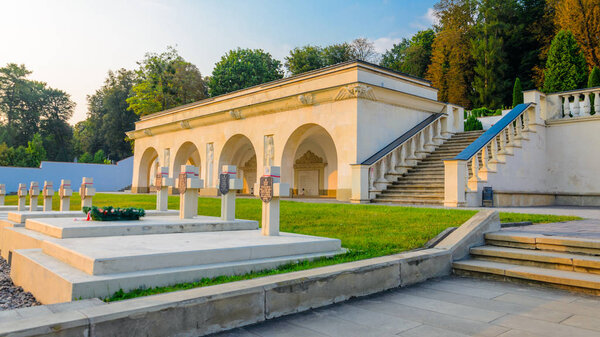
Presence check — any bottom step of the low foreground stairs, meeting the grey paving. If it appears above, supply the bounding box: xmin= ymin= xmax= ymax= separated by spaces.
xmin=452 ymin=259 xmax=600 ymax=291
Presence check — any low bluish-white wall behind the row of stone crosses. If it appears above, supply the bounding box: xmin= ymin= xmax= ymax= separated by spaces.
xmin=0 ymin=157 xmax=133 ymax=193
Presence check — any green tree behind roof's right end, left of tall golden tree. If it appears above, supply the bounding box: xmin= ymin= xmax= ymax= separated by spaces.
xmin=379 ymin=29 xmax=435 ymax=77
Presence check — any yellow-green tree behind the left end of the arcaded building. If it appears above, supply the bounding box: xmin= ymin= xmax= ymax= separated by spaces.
xmin=127 ymin=47 xmax=207 ymax=116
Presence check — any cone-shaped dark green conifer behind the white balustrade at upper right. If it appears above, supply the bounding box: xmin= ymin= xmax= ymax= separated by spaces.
xmin=543 ymin=30 xmax=587 ymax=93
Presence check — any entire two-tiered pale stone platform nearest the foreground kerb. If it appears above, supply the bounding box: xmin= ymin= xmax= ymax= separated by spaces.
xmin=11 ymin=230 xmax=344 ymax=304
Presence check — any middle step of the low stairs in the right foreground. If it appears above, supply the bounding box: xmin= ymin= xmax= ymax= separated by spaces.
xmin=471 ymin=246 xmax=600 ymax=274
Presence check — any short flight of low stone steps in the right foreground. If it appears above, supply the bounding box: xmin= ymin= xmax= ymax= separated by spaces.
xmin=453 ymin=230 xmax=600 ymax=295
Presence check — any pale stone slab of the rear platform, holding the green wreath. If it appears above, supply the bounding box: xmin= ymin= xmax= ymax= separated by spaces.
xmin=25 ymin=215 xmax=258 ymax=239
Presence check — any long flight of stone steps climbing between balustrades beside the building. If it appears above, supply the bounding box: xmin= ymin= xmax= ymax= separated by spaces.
xmin=373 ymin=130 xmax=483 ymax=205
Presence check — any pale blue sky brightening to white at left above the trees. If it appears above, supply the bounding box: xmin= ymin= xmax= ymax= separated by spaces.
xmin=0 ymin=0 xmax=437 ymax=124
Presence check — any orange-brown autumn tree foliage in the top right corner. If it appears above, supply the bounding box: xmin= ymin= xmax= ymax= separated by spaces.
xmin=556 ymin=0 xmax=600 ymax=69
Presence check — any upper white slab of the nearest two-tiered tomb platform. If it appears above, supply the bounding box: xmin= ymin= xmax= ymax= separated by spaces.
xmin=42 ymin=230 xmax=341 ymax=275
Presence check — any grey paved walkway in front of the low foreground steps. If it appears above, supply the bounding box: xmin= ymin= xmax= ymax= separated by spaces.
xmin=216 ymin=276 xmax=600 ymax=337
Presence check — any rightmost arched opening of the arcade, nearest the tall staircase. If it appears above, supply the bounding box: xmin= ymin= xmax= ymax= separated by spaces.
xmin=281 ymin=124 xmax=337 ymax=197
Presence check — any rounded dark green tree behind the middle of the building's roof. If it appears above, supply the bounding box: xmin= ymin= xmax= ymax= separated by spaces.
xmin=208 ymin=48 xmax=283 ymax=96
